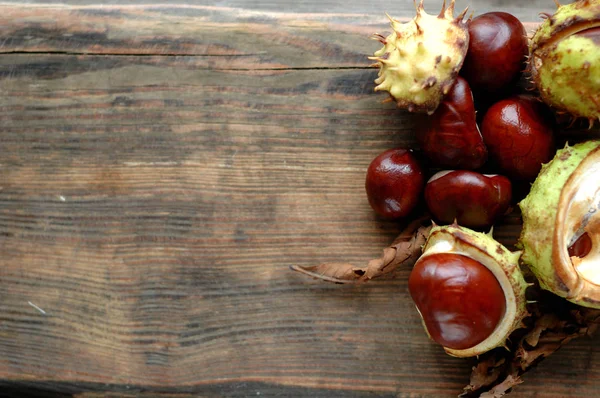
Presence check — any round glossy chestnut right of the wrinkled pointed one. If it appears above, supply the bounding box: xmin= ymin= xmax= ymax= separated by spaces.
xmin=481 ymin=95 xmax=556 ymax=181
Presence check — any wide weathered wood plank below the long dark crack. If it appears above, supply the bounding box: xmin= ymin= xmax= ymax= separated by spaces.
xmin=0 ymin=54 xmax=468 ymax=393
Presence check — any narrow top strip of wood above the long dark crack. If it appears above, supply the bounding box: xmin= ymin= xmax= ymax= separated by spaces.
xmin=0 ymin=4 xmax=535 ymax=66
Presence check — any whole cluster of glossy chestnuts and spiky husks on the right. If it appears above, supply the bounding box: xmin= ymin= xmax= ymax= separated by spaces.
xmin=365 ymin=0 xmax=600 ymax=357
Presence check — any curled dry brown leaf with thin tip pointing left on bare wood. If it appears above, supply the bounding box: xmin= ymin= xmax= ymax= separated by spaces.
xmin=290 ymin=218 xmax=431 ymax=283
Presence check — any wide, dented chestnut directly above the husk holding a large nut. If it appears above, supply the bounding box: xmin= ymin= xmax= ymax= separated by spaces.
xmin=425 ymin=170 xmax=512 ymax=230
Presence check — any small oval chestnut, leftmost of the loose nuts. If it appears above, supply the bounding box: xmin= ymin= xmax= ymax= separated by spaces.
xmin=365 ymin=148 xmax=425 ymax=219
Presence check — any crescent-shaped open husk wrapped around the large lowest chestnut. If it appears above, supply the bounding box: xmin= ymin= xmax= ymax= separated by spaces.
xmin=414 ymin=224 xmax=529 ymax=357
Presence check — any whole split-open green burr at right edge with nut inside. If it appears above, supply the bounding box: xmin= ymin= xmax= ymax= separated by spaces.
xmin=518 ymin=141 xmax=600 ymax=308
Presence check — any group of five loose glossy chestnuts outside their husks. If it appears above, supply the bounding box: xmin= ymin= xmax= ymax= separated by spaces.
xmin=366 ymin=4 xmax=556 ymax=230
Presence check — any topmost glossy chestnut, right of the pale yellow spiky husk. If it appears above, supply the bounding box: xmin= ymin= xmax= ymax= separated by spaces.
xmin=461 ymin=12 xmax=528 ymax=93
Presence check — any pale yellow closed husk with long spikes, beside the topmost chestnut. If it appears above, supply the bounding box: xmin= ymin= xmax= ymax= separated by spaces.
xmin=370 ymin=0 xmax=469 ymax=114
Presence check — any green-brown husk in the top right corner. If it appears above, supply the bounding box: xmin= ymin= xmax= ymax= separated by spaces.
xmin=530 ymin=0 xmax=600 ymax=124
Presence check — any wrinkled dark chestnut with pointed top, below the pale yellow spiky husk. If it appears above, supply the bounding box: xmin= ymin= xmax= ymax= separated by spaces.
xmin=419 ymin=77 xmax=487 ymax=170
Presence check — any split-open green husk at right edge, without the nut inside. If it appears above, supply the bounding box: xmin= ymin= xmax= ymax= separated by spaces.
xmin=518 ymin=141 xmax=600 ymax=308
